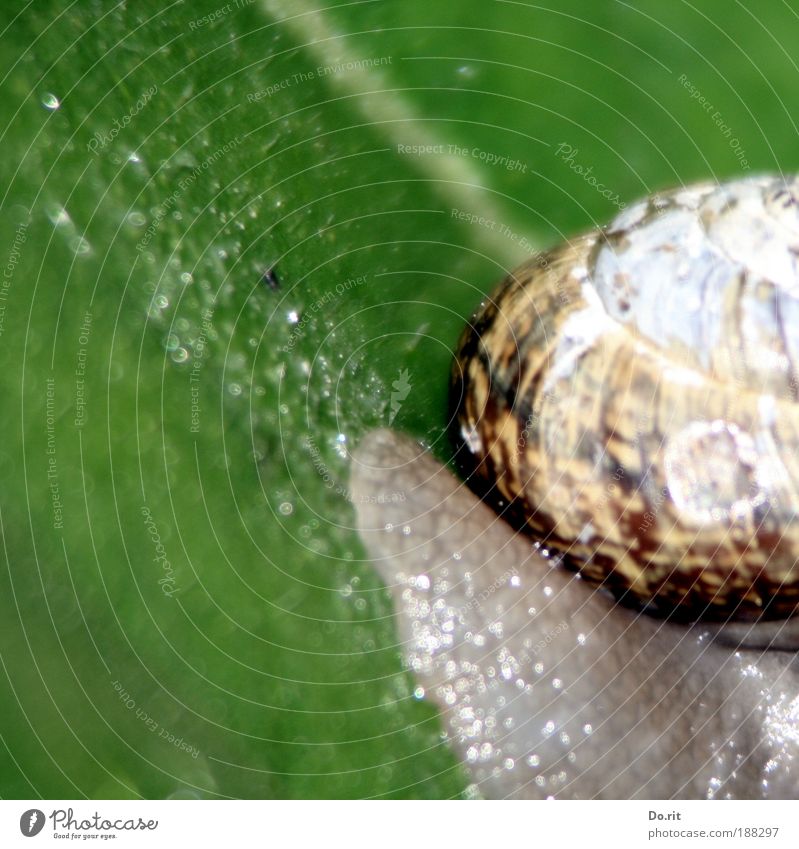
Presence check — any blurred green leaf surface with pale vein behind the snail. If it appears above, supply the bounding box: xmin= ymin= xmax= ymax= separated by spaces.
xmin=0 ymin=0 xmax=799 ymax=798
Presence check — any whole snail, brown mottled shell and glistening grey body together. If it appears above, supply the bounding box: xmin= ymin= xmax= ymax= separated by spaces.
xmin=350 ymin=177 xmax=799 ymax=799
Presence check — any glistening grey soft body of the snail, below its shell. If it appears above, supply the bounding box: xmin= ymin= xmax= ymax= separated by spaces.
xmin=351 ymin=431 xmax=799 ymax=798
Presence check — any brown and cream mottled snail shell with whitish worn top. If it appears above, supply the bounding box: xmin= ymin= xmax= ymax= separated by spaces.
xmin=452 ymin=177 xmax=799 ymax=619
